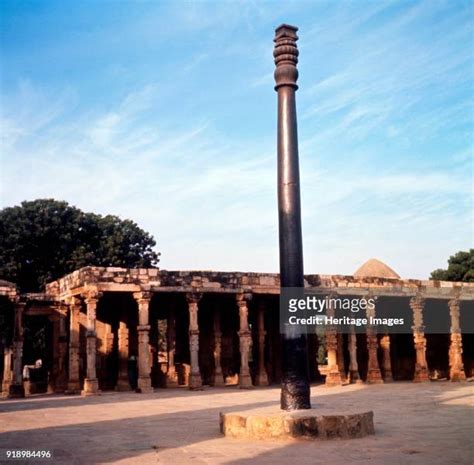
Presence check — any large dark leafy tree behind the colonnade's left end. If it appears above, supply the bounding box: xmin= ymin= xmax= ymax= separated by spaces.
xmin=0 ymin=199 xmax=159 ymax=292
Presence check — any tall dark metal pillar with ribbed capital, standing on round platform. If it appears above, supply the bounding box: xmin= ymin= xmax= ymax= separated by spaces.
xmin=273 ymin=24 xmax=311 ymax=410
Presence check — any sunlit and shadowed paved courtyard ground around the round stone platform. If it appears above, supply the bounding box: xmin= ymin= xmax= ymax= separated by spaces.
xmin=0 ymin=382 xmax=474 ymax=465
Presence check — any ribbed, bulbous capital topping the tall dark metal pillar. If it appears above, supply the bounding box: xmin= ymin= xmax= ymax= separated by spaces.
xmin=273 ymin=24 xmax=299 ymax=90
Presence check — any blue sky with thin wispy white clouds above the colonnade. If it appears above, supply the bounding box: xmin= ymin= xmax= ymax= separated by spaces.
xmin=0 ymin=0 xmax=474 ymax=278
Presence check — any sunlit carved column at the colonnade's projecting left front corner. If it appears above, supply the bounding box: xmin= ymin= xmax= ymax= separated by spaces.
xmin=82 ymin=291 xmax=101 ymax=396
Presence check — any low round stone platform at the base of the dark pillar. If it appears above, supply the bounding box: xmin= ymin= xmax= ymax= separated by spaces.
xmin=219 ymin=408 xmax=375 ymax=439
